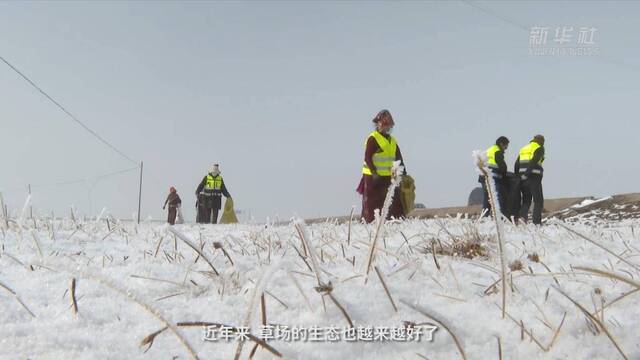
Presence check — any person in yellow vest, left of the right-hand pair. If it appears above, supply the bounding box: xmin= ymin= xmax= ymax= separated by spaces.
xmin=478 ymin=136 xmax=509 ymax=217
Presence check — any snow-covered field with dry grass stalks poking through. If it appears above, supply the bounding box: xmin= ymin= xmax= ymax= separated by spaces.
xmin=0 ymin=214 xmax=640 ymax=359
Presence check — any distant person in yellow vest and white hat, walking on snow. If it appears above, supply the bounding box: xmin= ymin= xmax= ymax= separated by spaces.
xmin=196 ymin=164 xmax=231 ymax=224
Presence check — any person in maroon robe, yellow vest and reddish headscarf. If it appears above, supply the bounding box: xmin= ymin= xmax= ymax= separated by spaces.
xmin=356 ymin=110 xmax=406 ymax=223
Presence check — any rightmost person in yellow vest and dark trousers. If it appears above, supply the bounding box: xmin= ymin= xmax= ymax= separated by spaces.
xmin=514 ymin=135 xmax=545 ymax=225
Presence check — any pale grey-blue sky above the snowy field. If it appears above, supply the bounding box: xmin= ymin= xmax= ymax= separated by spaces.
xmin=0 ymin=1 xmax=640 ymax=220
